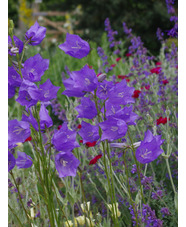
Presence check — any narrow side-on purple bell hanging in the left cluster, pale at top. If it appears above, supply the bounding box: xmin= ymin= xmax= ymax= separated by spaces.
xmin=39 ymin=104 xmax=53 ymax=129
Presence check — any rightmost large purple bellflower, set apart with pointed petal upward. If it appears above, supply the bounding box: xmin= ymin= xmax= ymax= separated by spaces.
xmin=136 ymin=130 xmax=164 ymax=164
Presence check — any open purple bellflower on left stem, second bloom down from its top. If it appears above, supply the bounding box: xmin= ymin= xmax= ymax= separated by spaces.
xmin=21 ymin=54 xmax=49 ymax=82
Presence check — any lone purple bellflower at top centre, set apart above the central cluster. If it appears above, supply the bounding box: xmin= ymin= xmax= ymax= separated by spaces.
xmin=59 ymin=33 xmax=90 ymax=59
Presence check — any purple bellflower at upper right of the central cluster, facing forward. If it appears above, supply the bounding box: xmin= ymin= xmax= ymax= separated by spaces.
xmin=108 ymin=80 xmax=135 ymax=105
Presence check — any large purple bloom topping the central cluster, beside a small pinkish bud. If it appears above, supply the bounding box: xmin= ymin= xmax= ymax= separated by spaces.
xmin=62 ymin=65 xmax=98 ymax=97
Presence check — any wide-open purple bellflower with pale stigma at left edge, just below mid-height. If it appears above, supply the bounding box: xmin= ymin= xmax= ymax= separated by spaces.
xmin=8 ymin=119 xmax=31 ymax=147
